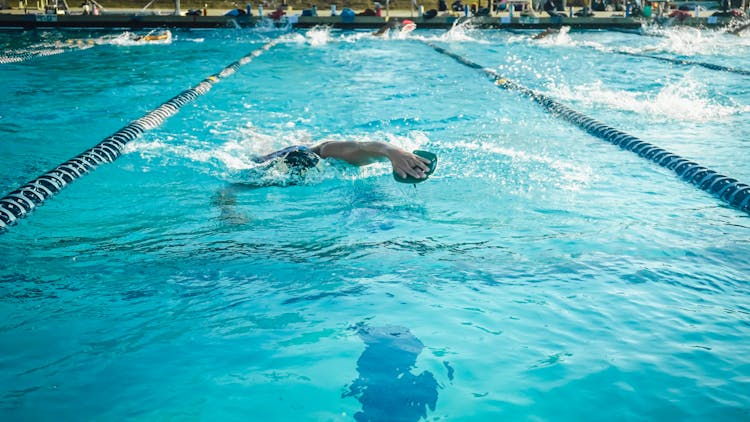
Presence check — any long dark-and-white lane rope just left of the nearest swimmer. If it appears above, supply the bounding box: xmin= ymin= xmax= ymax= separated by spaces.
xmin=0 ymin=38 xmax=279 ymax=233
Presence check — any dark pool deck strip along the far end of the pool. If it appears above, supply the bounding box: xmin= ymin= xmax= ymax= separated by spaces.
xmin=0 ymin=9 xmax=730 ymax=30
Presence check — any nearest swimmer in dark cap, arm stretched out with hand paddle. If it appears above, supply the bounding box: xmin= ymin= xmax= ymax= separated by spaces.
xmin=254 ymin=141 xmax=434 ymax=181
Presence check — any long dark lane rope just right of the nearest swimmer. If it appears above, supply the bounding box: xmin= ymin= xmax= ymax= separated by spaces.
xmin=423 ymin=41 xmax=750 ymax=213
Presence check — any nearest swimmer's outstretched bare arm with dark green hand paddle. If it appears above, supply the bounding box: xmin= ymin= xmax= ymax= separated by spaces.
xmin=312 ymin=141 xmax=430 ymax=179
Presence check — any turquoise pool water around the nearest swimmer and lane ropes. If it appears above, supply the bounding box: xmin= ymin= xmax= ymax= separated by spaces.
xmin=0 ymin=28 xmax=750 ymax=421
